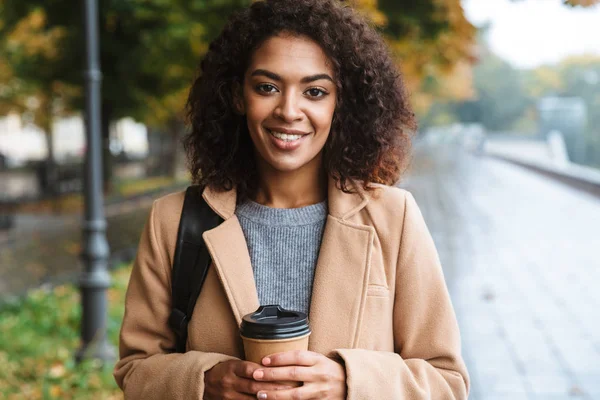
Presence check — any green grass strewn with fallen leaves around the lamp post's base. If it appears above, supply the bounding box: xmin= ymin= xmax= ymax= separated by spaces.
xmin=0 ymin=267 xmax=131 ymax=400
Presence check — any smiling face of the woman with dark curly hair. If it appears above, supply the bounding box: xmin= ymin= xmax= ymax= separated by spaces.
xmin=236 ymin=35 xmax=336 ymax=177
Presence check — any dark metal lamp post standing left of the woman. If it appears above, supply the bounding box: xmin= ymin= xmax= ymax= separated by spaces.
xmin=76 ymin=0 xmax=116 ymax=362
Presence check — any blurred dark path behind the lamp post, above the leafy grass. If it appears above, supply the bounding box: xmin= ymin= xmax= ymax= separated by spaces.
xmin=0 ymin=189 xmax=174 ymax=298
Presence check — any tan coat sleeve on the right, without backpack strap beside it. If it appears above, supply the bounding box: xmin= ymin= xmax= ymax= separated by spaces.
xmin=336 ymin=192 xmax=469 ymax=400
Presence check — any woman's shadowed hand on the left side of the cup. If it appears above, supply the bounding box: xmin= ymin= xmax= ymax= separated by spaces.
xmin=204 ymin=360 xmax=291 ymax=400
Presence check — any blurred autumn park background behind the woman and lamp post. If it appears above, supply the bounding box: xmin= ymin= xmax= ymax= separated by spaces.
xmin=0 ymin=0 xmax=600 ymax=400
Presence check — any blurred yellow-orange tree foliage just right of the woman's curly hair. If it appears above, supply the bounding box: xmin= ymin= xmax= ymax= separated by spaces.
xmin=379 ymin=0 xmax=476 ymax=115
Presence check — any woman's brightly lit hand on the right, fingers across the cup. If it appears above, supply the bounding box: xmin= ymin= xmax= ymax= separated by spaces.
xmin=252 ymin=351 xmax=346 ymax=400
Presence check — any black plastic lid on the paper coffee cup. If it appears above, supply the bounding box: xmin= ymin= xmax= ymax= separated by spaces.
xmin=240 ymin=305 xmax=310 ymax=340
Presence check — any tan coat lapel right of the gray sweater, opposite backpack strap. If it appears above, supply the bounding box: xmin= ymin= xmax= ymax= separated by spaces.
xmin=309 ymin=182 xmax=374 ymax=353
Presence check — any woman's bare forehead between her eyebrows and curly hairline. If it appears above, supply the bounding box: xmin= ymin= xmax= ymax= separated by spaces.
xmin=248 ymin=34 xmax=333 ymax=76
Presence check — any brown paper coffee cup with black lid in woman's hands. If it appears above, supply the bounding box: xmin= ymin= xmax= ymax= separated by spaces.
xmin=240 ymin=305 xmax=311 ymax=385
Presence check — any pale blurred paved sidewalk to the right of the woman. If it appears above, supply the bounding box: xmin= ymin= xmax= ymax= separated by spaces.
xmin=401 ymin=145 xmax=600 ymax=400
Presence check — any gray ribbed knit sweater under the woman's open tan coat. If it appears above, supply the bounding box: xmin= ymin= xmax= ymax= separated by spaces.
xmin=235 ymin=200 xmax=327 ymax=313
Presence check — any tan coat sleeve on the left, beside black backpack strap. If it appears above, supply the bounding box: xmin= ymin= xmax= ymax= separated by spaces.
xmin=114 ymin=202 xmax=234 ymax=400
